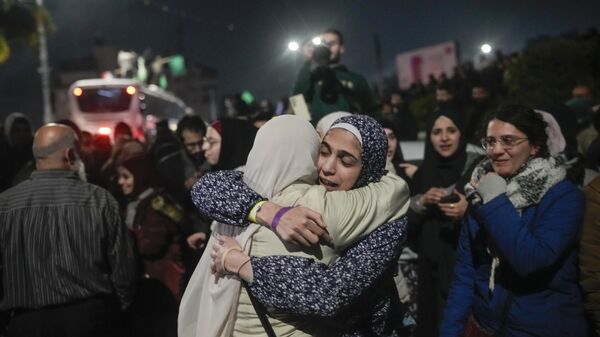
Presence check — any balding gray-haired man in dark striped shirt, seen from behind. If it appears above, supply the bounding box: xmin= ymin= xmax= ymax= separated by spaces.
xmin=0 ymin=124 xmax=136 ymax=337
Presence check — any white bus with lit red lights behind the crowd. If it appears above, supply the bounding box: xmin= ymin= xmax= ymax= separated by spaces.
xmin=68 ymin=78 xmax=192 ymax=141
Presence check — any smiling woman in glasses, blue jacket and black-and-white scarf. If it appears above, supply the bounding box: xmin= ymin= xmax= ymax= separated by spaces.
xmin=440 ymin=105 xmax=587 ymax=337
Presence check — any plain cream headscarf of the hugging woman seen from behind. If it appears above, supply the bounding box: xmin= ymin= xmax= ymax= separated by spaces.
xmin=177 ymin=115 xmax=319 ymax=337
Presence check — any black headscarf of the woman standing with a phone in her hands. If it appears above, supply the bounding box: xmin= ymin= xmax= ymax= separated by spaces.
xmin=411 ymin=109 xmax=467 ymax=195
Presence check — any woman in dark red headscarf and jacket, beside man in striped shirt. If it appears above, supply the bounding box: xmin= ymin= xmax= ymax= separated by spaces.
xmin=117 ymin=155 xmax=188 ymax=336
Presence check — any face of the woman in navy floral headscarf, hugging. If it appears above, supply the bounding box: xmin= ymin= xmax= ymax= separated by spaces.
xmin=317 ymin=128 xmax=362 ymax=191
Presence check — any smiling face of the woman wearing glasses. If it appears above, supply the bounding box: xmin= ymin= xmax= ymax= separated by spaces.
xmin=486 ymin=119 xmax=538 ymax=177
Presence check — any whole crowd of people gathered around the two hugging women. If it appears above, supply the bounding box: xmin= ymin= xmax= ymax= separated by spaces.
xmin=0 ymin=25 xmax=600 ymax=337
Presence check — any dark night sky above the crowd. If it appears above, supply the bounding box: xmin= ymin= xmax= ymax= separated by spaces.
xmin=0 ymin=0 xmax=600 ymax=125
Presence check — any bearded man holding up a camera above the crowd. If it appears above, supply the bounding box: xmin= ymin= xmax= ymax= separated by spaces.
xmin=292 ymin=29 xmax=378 ymax=123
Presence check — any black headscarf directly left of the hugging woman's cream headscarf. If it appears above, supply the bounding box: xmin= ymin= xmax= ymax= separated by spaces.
xmin=212 ymin=118 xmax=257 ymax=171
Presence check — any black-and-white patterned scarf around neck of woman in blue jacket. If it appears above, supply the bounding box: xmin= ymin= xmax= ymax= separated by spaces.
xmin=465 ymin=157 xmax=567 ymax=291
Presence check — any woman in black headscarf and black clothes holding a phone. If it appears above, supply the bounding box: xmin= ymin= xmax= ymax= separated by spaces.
xmin=409 ymin=109 xmax=481 ymax=336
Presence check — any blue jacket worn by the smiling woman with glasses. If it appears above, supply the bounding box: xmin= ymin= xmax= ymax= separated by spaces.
xmin=440 ymin=181 xmax=587 ymax=337
